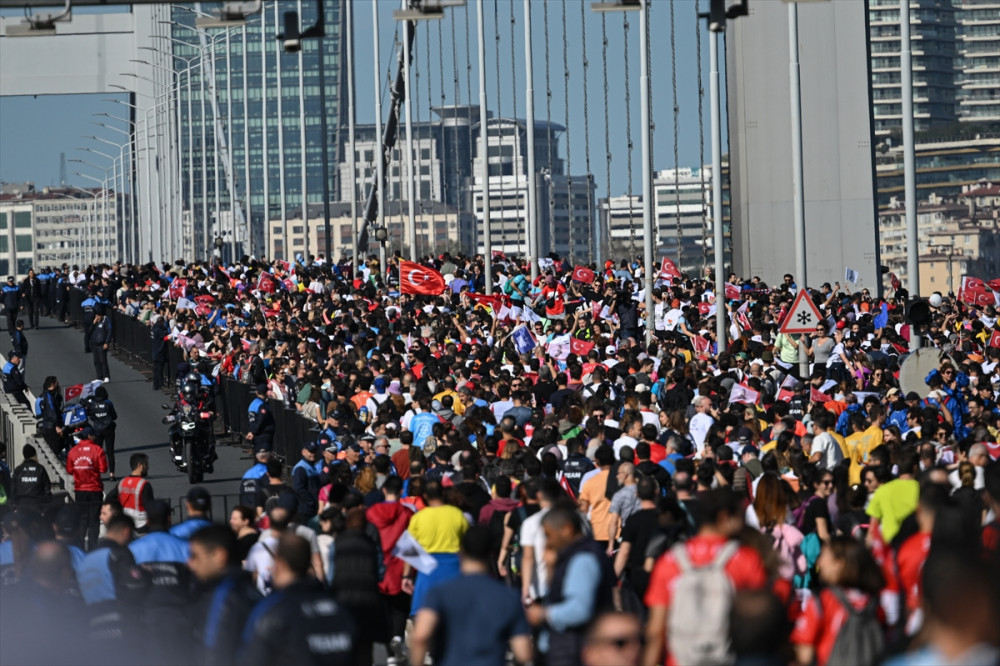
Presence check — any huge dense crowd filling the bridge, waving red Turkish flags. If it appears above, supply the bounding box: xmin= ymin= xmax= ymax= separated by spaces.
xmin=0 ymin=254 xmax=1000 ymax=666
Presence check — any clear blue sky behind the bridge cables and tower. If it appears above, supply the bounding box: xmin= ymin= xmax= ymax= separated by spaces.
xmin=0 ymin=0 xmax=726 ymax=196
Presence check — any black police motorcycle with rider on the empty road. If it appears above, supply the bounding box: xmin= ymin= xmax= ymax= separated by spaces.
xmin=163 ymin=374 xmax=217 ymax=484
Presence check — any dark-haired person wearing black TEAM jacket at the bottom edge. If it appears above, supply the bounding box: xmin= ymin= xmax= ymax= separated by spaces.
xmin=238 ymin=534 xmax=358 ymax=666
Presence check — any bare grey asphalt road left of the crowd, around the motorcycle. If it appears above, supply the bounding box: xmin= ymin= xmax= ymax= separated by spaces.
xmin=14 ymin=317 xmax=253 ymax=512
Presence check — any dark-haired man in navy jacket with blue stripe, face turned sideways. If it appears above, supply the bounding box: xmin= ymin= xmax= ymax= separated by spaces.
xmin=188 ymin=525 xmax=260 ymax=666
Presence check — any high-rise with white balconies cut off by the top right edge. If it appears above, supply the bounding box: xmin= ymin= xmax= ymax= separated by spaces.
xmin=957 ymin=0 xmax=1000 ymax=126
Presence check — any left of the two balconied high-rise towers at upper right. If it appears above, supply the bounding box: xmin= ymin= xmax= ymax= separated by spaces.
xmin=868 ymin=0 xmax=958 ymax=137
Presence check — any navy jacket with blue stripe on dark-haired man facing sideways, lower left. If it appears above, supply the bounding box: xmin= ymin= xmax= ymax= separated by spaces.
xmin=194 ymin=568 xmax=260 ymax=666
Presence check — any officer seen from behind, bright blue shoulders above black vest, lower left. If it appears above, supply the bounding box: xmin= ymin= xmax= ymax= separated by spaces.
xmin=129 ymin=498 xmax=195 ymax=664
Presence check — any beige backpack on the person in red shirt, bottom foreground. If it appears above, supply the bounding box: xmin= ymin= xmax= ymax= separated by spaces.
xmin=667 ymin=541 xmax=739 ymax=666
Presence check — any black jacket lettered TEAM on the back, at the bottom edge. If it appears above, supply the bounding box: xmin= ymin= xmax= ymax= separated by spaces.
xmin=237 ymin=580 xmax=358 ymax=666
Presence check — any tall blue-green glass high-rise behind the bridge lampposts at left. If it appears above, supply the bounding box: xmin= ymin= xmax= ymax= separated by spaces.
xmin=168 ymin=0 xmax=347 ymax=254
